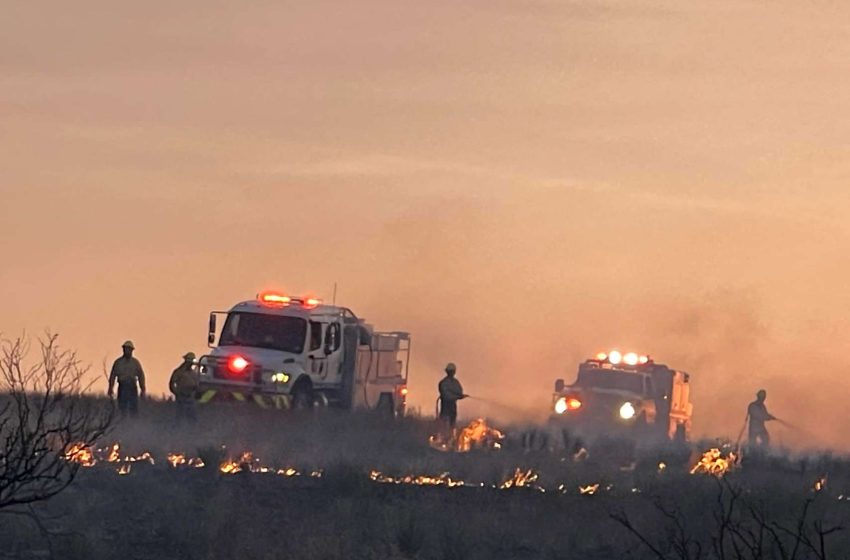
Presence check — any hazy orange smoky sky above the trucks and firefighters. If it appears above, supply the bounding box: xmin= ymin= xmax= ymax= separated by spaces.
xmin=0 ymin=0 xmax=850 ymax=449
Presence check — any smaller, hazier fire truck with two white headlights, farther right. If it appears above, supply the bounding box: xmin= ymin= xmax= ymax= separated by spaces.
xmin=551 ymin=350 xmax=693 ymax=441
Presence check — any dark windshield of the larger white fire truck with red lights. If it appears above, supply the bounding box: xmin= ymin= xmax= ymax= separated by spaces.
xmin=218 ymin=312 xmax=307 ymax=354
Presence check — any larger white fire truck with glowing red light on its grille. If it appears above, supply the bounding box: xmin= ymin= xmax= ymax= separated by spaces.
xmin=198 ymin=292 xmax=410 ymax=415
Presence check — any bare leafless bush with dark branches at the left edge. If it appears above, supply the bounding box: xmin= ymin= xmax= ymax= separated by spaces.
xmin=0 ymin=333 xmax=113 ymax=510
